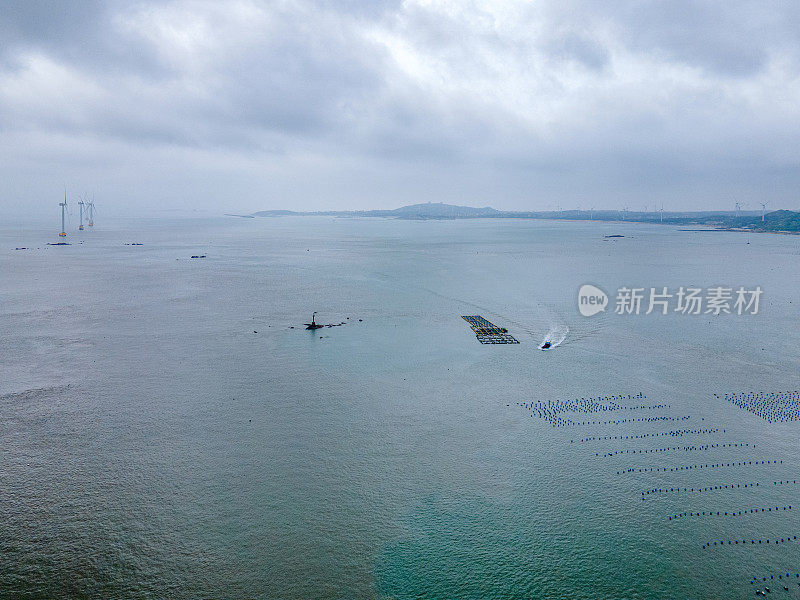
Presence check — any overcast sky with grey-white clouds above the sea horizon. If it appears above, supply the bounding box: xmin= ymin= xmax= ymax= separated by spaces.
xmin=0 ymin=0 xmax=800 ymax=213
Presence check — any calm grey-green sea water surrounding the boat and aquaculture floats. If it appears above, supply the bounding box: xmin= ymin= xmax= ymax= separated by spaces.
xmin=0 ymin=217 xmax=800 ymax=598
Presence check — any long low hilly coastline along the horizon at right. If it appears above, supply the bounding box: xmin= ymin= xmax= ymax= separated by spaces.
xmin=245 ymin=202 xmax=800 ymax=233
